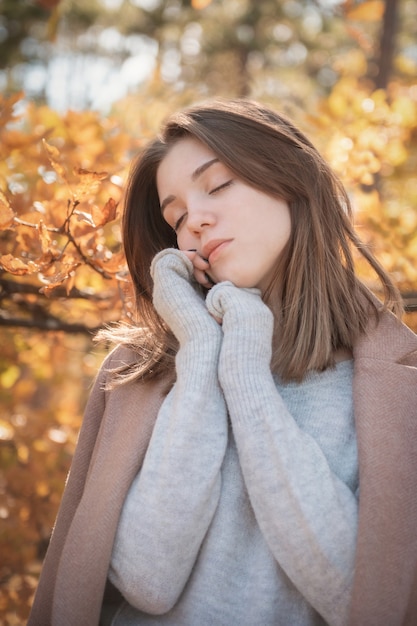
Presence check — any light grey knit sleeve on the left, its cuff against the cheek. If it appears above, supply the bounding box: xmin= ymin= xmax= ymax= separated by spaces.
xmin=105 ymin=247 xmax=227 ymax=614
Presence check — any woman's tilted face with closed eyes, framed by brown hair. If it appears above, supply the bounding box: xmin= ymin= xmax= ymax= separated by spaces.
xmin=157 ymin=137 xmax=291 ymax=291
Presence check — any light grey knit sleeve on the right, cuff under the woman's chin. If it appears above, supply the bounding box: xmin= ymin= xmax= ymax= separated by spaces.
xmin=207 ymin=283 xmax=357 ymax=626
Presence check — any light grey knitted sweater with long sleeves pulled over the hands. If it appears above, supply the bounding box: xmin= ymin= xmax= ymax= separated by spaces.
xmin=109 ymin=251 xmax=358 ymax=626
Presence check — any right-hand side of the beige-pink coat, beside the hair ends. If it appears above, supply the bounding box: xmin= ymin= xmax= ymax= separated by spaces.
xmin=351 ymin=313 xmax=417 ymax=626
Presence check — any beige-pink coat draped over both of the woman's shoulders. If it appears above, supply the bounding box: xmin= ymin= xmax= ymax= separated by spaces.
xmin=28 ymin=314 xmax=417 ymax=626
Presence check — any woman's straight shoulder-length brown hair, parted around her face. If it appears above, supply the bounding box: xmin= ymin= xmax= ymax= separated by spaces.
xmin=99 ymin=100 xmax=401 ymax=380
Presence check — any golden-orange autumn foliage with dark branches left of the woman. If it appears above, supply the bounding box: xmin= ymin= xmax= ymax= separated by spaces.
xmin=0 ymin=83 xmax=195 ymax=624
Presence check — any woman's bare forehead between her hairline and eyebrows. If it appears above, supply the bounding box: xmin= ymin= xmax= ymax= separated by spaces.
xmin=156 ymin=137 xmax=216 ymax=192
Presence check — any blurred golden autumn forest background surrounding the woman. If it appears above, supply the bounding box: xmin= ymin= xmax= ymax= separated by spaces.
xmin=0 ymin=0 xmax=417 ymax=625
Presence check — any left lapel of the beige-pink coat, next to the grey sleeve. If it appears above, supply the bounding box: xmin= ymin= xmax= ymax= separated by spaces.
xmin=52 ymin=351 xmax=167 ymax=626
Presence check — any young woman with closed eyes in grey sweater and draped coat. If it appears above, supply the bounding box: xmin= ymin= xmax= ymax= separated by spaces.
xmin=29 ymin=100 xmax=417 ymax=626
